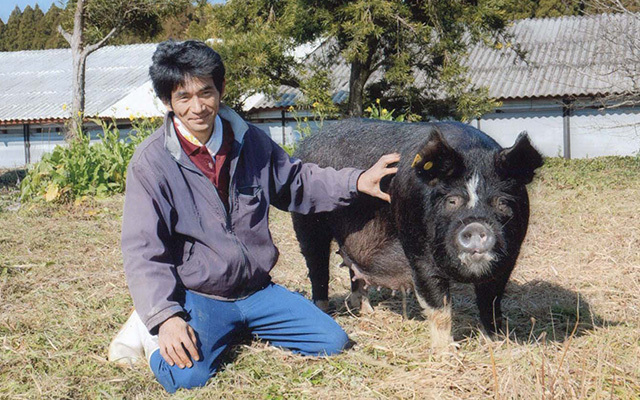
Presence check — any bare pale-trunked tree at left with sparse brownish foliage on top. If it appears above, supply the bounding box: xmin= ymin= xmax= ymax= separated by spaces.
xmin=58 ymin=0 xmax=186 ymax=138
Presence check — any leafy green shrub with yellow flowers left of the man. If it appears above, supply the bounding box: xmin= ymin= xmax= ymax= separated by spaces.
xmin=20 ymin=118 xmax=160 ymax=203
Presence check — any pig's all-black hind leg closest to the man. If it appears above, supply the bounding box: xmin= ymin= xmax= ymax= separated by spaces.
xmin=292 ymin=214 xmax=333 ymax=312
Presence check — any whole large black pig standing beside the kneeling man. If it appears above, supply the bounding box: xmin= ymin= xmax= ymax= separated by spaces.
xmin=293 ymin=119 xmax=543 ymax=347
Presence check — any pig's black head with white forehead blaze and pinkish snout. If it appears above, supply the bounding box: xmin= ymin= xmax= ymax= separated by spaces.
xmin=396 ymin=130 xmax=542 ymax=282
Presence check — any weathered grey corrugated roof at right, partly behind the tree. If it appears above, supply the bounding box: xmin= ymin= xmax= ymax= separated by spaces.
xmin=252 ymin=14 xmax=640 ymax=109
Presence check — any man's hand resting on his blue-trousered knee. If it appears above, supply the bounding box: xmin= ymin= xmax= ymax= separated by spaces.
xmin=158 ymin=315 xmax=200 ymax=368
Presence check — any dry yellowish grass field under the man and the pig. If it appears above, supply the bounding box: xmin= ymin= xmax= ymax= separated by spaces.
xmin=0 ymin=158 xmax=640 ymax=399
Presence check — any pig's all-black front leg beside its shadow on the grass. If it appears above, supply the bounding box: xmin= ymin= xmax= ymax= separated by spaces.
xmin=475 ymin=275 xmax=509 ymax=336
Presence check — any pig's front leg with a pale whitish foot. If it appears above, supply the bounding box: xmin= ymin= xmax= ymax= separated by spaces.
xmin=414 ymin=274 xmax=453 ymax=349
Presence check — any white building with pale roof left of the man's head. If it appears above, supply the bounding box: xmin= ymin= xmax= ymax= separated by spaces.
xmin=0 ymin=44 xmax=165 ymax=168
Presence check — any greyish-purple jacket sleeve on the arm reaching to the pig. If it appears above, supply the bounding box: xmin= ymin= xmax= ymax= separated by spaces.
xmin=270 ymin=140 xmax=363 ymax=214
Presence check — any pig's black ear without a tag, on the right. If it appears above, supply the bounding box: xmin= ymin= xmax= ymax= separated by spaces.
xmin=496 ymin=132 xmax=543 ymax=185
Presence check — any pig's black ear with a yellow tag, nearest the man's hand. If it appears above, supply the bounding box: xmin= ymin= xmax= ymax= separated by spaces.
xmin=411 ymin=128 xmax=464 ymax=186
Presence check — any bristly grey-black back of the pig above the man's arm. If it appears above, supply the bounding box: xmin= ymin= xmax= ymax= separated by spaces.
xmin=294 ymin=119 xmax=500 ymax=169
